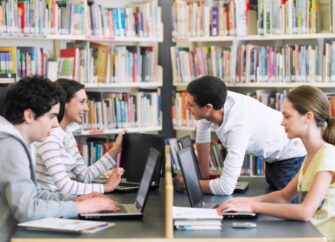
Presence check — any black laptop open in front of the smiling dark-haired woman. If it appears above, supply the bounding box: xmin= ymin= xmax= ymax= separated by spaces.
xmin=115 ymin=133 xmax=164 ymax=191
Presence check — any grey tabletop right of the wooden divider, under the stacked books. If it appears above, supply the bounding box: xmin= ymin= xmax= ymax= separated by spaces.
xmin=174 ymin=177 xmax=324 ymax=241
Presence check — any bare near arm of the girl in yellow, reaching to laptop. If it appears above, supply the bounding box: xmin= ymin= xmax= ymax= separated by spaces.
xmin=220 ymin=171 xmax=333 ymax=221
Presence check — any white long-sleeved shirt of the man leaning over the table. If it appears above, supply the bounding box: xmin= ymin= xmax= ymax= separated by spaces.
xmin=196 ymin=91 xmax=306 ymax=195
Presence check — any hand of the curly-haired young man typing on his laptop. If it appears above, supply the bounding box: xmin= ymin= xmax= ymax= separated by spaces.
xmin=76 ymin=195 xmax=120 ymax=213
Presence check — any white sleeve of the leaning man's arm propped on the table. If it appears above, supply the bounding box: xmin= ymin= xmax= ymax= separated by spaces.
xmin=209 ymin=126 xmax=250 ymax=195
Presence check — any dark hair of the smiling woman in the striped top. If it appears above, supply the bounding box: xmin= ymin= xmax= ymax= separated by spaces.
xmin=55 ymin=78 xmax=85 ymax=123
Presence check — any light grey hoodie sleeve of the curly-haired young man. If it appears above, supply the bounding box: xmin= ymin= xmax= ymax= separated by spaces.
xmin=0 ymin=140 xmax=78 ymax=222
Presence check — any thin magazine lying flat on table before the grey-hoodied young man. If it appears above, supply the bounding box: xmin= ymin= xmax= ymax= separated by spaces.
xmin=18 ymin=218 xmax=115 ymax=233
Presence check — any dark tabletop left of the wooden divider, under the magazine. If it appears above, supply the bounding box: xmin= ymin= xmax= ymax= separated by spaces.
xmin=12 ymin=179 xmax=165 ymax=242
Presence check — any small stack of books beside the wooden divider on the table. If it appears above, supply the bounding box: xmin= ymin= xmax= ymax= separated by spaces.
xmin=173 ymin=207 xmax=222 ymax=230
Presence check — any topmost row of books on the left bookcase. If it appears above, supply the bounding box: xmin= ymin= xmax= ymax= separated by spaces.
xmin=0 ymin=0 xmax=161 ymax=38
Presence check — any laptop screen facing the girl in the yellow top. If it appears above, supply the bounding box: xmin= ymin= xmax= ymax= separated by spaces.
xmin=178 ymin=147 xmax=204 ymax=207
